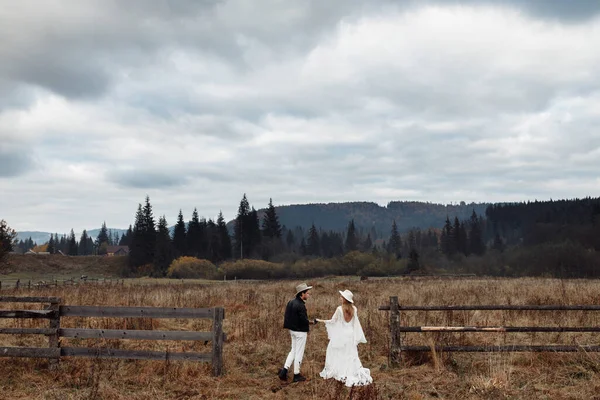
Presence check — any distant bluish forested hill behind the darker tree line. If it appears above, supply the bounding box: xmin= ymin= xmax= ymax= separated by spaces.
xmin=270 ymin=201 xmax=491 ymax=235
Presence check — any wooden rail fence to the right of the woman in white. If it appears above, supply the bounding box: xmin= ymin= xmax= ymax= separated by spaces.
xmin=379 ymin=296 xmax=600 ymax=366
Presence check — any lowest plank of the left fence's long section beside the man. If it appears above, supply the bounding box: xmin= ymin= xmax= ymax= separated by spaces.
xmin=60 ymin=347 xmax=212 ymax=362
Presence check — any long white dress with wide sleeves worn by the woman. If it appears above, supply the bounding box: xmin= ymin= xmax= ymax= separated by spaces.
xmin=320 ymin=306 xmax=373 ymax=387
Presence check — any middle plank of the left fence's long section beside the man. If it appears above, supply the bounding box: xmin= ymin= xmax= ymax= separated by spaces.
xmin=59 ymin=328 xmax=213 ymax=341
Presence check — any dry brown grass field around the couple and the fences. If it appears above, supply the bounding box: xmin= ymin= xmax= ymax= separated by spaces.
xmin=0 ymin=278 xmax=600 ymax=400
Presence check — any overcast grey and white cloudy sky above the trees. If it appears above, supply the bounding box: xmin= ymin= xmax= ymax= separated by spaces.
xmin=0 ymin=0 xmax=600 ymax=232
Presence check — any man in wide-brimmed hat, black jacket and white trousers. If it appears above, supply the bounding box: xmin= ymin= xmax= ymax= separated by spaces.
xmin=278 ymin=283 xmax=316 ymax=382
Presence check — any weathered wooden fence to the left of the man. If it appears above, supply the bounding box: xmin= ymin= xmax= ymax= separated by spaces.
xmin=0 ymin=296 xmax=226 ymax=376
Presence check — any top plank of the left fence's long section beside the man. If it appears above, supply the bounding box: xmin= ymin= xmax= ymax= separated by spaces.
xmin=60 ymin=306 xmax=213 ymax=318
